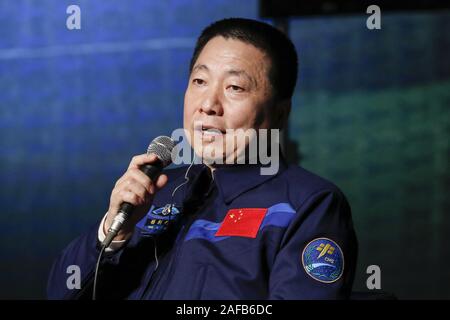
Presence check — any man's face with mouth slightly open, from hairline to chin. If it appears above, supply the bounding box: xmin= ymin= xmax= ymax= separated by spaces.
xmin=184 ymin=37 xmax=272 ymax=161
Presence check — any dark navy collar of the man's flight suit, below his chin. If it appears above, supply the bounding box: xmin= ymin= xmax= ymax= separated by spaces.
xmin=184 ymin=157 xmax=286 ymax=204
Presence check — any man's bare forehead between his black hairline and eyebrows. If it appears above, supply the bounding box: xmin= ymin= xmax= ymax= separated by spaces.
xmin=192 ymin=36 xmax=270 ymax=80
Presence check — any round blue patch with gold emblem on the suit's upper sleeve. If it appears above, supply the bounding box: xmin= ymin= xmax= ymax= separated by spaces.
xmin=302 ymin=238 xmax=344 ymax=283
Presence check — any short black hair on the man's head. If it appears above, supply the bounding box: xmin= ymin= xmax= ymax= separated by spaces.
xmin=189 ymin=18 xmax=298 ymax=101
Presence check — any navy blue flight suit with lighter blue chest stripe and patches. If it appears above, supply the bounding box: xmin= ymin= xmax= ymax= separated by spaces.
xmin=47 ymin=162 xmax=357 ymax=299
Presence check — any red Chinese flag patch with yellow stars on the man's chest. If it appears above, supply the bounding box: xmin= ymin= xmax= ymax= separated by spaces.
xmin=216 ymin=208 xmax=267 ymax=238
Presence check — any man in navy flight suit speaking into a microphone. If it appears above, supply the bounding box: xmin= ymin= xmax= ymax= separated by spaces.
xmin=48 ymin=18 xmax=357 ymax=299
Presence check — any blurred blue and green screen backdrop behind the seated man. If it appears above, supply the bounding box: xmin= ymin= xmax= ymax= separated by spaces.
xmin=0 ymin=0 xmax=450 ymax=298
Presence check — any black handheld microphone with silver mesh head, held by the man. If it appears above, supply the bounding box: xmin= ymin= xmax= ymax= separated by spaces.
xmin=102 ymin=136 xmax=175 ymax=247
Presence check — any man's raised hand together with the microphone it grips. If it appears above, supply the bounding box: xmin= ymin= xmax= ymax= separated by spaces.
xmin=102 ymin=136 xmax=174 ymax=247
